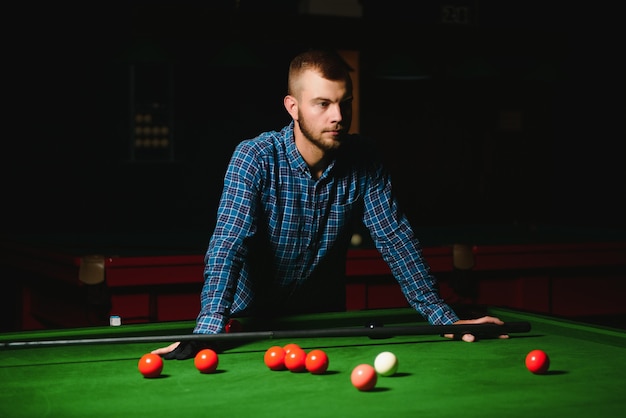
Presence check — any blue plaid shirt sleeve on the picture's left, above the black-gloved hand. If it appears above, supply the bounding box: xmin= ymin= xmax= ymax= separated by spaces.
xmin=194 ymin=142 xmax=259 ymax=334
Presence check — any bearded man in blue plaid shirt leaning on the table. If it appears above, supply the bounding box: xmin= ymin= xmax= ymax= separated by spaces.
xmin=154 ymin=50 xmax=506 ymax=359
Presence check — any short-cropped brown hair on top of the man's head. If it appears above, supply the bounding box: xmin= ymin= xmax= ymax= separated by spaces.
xmin=287 ymin=49 xmax=352 ymax=95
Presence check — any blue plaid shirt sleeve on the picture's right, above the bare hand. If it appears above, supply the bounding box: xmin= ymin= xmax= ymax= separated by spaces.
xmin=363 ymin=165 xmax=459 ymax=325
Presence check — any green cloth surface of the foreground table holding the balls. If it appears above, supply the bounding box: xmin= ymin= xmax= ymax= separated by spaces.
xmin=0 ymin=308 xmax=626 ymax=418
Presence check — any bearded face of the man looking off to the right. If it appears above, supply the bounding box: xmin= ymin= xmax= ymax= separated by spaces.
xmin=296 ymin=71 xmax=352 ymax=151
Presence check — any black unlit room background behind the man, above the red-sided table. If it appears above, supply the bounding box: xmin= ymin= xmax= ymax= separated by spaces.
xmin=1 ymin=0 xmax=626 ymax=236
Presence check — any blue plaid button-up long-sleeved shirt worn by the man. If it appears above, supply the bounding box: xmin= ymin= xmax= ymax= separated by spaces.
xmin=194 ymin=122 xmax=459 ymax=334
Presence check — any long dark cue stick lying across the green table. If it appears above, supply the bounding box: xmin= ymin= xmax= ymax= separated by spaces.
xmin=0 ymin=321 xmax=531 ymax=348
